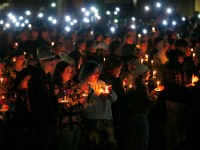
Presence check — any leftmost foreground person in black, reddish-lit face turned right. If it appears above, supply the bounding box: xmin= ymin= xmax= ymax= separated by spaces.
xmin=6 ymin=68 xmax=32 ymax=150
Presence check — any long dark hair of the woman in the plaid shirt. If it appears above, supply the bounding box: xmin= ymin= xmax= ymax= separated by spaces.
xmin=52 ymin=61 xmax=71 ymax=86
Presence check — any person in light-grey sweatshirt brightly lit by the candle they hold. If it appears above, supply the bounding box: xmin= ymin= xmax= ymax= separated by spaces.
xmin=79 ymin=61 xmax=117 ymax=150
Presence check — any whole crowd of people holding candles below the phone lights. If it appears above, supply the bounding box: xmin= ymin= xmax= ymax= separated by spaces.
xmin=0 ymin=6 xmax=200 ymax=150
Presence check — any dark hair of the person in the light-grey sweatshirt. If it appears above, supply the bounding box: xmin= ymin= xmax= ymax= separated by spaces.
xmin=79 ymin=60 xmax=101 ymax=80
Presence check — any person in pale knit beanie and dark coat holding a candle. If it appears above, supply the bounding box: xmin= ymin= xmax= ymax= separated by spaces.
xmin=127 ymin=64 xmax=158 ymax=150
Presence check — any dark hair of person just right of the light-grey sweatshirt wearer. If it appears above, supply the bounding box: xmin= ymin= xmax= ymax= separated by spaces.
xmin=103 ymin=57 xmax=123 ymax=72
